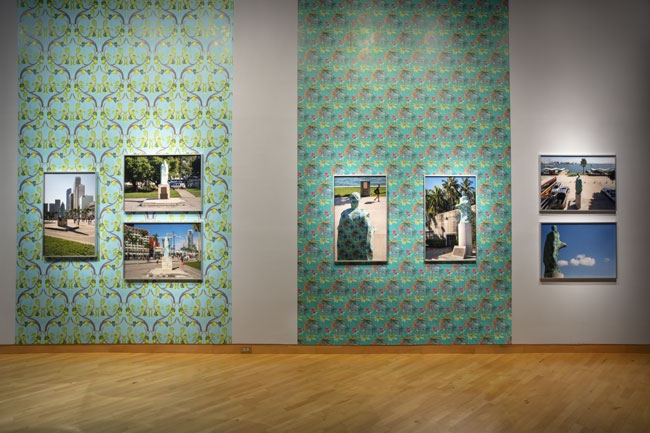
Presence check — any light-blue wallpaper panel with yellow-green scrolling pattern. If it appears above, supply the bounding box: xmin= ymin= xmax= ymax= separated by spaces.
xmin=16 ymin=0 xmax=233 ymax=344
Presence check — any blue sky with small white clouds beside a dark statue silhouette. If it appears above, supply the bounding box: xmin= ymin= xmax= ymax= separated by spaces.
xmin=540 ymin=223 xmax=616 ymax=278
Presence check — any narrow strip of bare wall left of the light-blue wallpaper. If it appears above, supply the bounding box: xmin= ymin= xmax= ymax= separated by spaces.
xmin=0 ymin=1 xmax=18 ymax=344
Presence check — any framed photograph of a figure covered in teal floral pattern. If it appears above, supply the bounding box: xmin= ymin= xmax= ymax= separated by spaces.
xmin=334 ymin=175 xmax=388 ymax=264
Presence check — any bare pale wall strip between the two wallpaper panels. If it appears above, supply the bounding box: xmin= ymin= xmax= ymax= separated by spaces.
xmin=232 ymin=0 xmax=298 ymax=344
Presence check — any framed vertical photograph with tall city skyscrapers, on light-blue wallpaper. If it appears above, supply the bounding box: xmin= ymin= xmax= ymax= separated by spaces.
xmin=43 ymin=172 xmax=97 ymax=260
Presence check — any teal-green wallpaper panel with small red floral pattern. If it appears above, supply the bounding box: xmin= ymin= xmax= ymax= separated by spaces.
xmin=298 ymin=0 xmax=512 ymax=344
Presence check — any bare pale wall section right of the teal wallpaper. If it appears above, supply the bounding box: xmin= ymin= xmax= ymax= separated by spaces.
xmin=510 ymin=0 xmax=650 ymax=344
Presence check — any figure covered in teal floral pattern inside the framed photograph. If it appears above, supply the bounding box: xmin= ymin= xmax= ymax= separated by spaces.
xmin=336 ymin=192 xmax=375 ymax=261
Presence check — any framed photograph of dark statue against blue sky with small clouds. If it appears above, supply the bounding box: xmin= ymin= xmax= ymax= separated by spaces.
xmin=540 ymin=223 xmax=616 ymax=282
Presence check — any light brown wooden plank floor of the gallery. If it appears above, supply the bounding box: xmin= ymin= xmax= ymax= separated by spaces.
xmin=0 ymin=353 xmax=650 ymax=433
